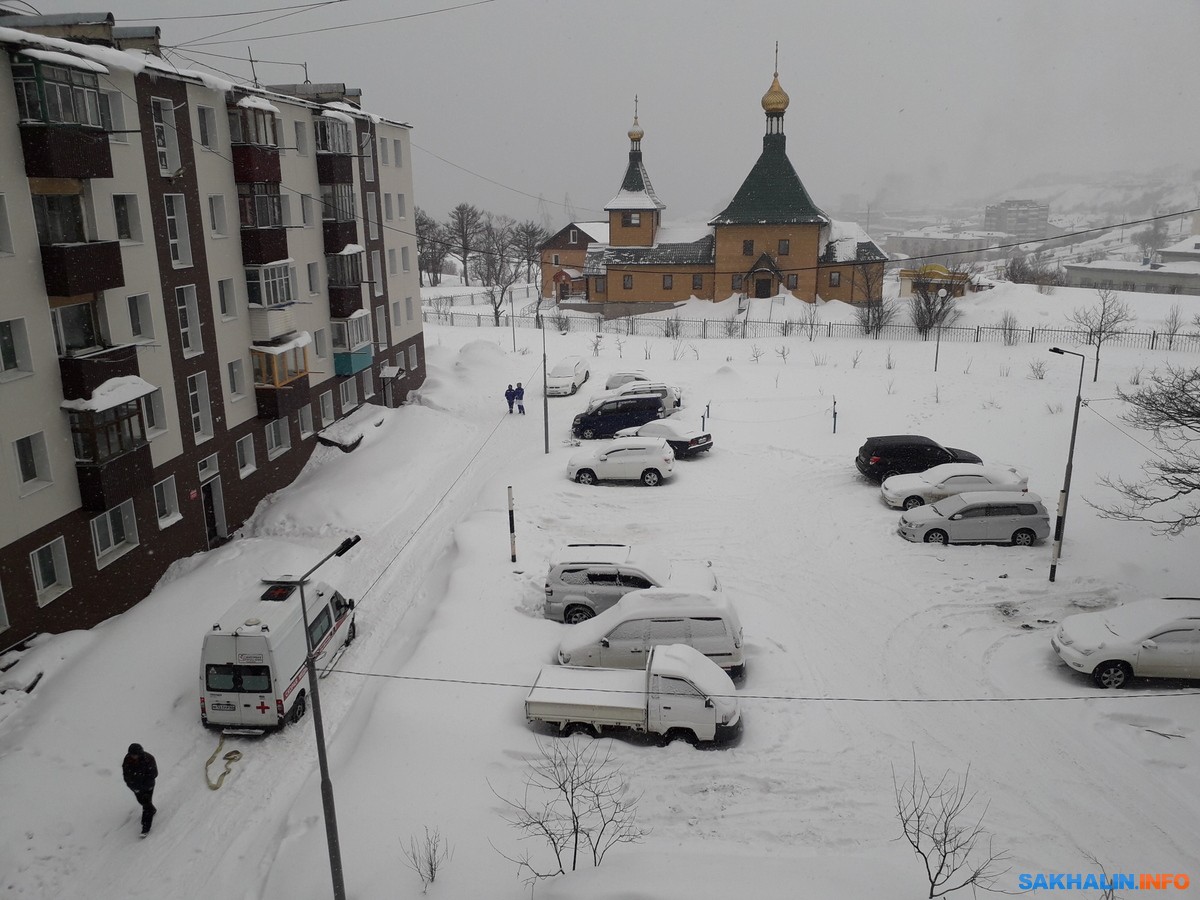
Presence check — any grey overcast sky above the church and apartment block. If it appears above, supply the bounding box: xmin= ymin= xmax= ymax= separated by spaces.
xmin=25 ymin=0 xmax=1200 ymax=228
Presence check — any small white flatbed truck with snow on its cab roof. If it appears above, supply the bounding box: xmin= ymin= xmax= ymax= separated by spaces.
xmin=526 ymin=644 xmax=742 ymax=743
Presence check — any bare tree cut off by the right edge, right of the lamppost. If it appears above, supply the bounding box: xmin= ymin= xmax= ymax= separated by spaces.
xmin=1087 ymin=367 xmax=1200 ymax=535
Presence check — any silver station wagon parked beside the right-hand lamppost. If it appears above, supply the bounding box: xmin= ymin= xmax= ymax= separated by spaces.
xmin=896 ymin=491 xmax=1050 ymax=547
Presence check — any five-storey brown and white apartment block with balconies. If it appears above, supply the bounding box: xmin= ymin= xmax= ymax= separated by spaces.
xmin=0 ymin=16 xmax=425 ymax=649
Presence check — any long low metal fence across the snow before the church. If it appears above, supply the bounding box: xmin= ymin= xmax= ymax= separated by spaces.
xmin=421 ymin=308 xmax=1200 ymax=353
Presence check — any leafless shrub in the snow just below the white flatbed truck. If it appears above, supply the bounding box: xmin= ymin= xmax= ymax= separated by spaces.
xmin=492 ymin=738 xmax=649 ymax=883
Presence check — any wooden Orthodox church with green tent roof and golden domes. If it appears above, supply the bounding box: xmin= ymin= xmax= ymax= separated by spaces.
xmin=541 ymin=72 xmax=887 ymax=314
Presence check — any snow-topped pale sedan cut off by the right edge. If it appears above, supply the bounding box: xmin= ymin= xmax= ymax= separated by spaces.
xmin=1050 ymin=596 xmax=1200 ymax=688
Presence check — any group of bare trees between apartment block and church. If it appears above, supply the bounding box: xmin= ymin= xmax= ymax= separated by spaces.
xmin=415 ymin=203 xmax=550 ymax=296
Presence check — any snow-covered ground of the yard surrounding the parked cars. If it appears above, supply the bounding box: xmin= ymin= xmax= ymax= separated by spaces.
xmin=0 ymin=286 xmax=1200 ymax=900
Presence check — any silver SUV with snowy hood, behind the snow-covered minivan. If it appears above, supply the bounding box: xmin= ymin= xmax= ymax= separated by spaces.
xmin=542 ymin=544 xmax=721 ymax=625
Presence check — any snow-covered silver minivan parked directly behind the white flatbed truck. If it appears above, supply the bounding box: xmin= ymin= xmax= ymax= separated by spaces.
xmin=558 ymin=588 xmax=745 ymax=678
